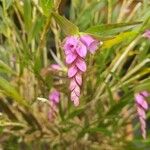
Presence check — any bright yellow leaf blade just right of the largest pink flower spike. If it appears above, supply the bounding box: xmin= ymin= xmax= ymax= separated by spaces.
xmin=102 ymin=31 xmax=137 ymax=49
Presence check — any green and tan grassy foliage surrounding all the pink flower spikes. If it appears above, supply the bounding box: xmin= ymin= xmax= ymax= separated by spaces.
xmin=0 ymin=0 xmax=150 ymax=150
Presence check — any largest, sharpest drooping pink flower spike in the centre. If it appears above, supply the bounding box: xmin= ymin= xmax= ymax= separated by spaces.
xmin=63 ymin=35 xmax=99 ymax=106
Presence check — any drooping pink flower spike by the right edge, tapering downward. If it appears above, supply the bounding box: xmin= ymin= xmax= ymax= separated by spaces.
xmin=135 ymin=91 xmax=150 ymax=139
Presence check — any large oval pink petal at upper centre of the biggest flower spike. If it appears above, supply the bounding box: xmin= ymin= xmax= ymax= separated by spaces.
xmin=76 ymin=43 xmax=87 ymax=58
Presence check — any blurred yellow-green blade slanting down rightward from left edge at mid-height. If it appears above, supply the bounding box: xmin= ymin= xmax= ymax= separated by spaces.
xmin=0 ymin=77 xmax=29 ymax=107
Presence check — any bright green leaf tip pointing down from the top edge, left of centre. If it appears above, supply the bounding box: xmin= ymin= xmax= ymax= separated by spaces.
xmin=41 ymin=0 xmax=54 ymax=16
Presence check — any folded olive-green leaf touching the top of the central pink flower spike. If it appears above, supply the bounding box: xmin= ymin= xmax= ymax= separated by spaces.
xmin=52 ymin=12 xmax=79 ymax=35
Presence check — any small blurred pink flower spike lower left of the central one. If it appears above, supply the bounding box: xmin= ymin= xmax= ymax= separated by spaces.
xmin=48 ymin=90 xmax=60 ymax=120
